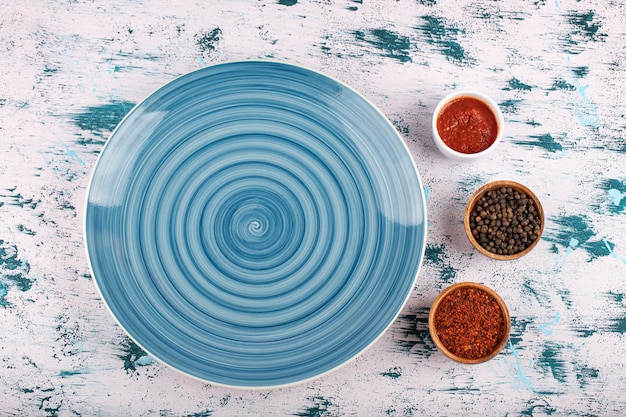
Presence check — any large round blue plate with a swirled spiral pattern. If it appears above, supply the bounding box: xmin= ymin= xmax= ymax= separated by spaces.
xmin=85 ymin=61 xmax=426 ymax=388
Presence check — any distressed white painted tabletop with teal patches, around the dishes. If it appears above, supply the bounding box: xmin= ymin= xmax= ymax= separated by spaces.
xmin=0 ymin=0 xmax=626 ymax=416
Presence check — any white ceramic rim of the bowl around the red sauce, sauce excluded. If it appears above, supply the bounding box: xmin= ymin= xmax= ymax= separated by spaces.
xmin=432 ymin=91 xmax=504 ymax=162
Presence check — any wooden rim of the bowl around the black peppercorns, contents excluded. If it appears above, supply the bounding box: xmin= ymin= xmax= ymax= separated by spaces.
xmin=463 ymin=180 xmax=545 ymax=261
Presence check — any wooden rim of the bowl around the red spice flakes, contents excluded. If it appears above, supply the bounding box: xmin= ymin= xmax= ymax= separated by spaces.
xmin=428 ymin=282 xmax=511 ymax=365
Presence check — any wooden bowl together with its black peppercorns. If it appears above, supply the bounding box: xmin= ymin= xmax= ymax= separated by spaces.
xmin=463 ymin=180 xmax=544 ymax=261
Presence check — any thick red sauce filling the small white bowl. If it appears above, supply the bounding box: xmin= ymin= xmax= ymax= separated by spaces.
xmin=437 ymin=97 xmax=498 ymax=154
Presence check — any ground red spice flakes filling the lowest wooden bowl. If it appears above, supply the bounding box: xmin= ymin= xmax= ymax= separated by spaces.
xmin=434 ymin=288 xmax=504 ymax=359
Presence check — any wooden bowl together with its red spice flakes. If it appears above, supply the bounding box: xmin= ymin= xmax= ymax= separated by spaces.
xmin=428 ymin=282 xmax=511 ymax=364
